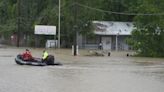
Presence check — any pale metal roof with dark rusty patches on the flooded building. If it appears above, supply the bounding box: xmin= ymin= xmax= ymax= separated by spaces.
xmin=93 ymin=21 xmax=134 ymax=35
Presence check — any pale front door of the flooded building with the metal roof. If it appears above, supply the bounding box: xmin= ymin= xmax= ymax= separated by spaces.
xmin=101 ymin=37 xmax=112 ymax=50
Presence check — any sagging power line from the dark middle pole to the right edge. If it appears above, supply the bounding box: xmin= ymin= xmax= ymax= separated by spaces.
xmin=73 ymin=3 xmax=164 ymax=16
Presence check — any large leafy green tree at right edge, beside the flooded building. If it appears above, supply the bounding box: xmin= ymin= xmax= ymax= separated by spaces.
xmin=129 ymin=0 xmax=164 ymax=57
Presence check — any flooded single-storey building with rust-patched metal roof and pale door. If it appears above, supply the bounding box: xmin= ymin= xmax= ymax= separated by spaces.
xmin=78 ymin=21 xmax=134 ymax=50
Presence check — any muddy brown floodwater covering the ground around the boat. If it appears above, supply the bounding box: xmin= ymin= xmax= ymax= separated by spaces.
xmin=0 ymin=48 xmax=164 ymax=92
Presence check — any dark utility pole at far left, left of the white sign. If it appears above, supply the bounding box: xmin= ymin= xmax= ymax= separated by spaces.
xmin=17 ymin=0 xmax=21 ymax=47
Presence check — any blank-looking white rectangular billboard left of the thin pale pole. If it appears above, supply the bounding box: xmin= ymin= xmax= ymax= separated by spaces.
xmin=34 ymin=25 xmax=56 ymax=35
